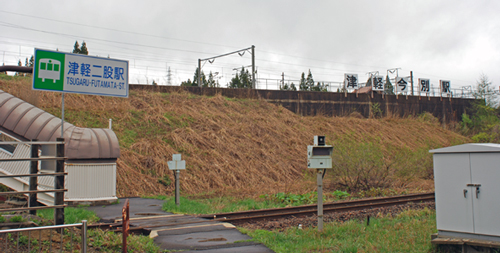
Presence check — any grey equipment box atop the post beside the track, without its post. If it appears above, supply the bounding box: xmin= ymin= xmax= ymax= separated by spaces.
xmin=307 ymin=136 xmax=333 ymax=169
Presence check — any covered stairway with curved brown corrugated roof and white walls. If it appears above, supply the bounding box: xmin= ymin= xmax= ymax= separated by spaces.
xmin=0 ymin=90 xmax=120 ymax=203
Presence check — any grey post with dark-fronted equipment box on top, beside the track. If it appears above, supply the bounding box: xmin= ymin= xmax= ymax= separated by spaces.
xmin=307 ymin=136 xmax=333 ymax=231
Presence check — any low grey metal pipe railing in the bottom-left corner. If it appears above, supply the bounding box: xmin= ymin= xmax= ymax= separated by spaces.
xmin=0 ymin=220 xmax=87 ymax=252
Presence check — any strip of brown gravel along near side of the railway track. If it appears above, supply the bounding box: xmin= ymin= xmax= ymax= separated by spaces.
xmin=233 ymin=202 xmax=435 ymax=231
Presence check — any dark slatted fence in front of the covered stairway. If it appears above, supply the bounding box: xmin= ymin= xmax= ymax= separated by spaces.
xmin=0 ymin=138 xmax=67 ymax=225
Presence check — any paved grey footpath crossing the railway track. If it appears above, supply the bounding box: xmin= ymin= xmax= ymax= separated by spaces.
xmin=88 ymin=198 xmax=273 ymax=253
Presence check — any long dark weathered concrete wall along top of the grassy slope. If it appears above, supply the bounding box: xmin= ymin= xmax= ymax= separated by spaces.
xmin=130 ymin=84 xmax=474 ymax=122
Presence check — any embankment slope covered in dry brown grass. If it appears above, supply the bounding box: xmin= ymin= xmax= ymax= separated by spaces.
xmin=0 ymin=78 xmax=467 ymax=199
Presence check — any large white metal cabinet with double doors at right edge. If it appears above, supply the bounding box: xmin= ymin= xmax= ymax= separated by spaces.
xmin=429 ymin=143 xmax=500 ymax=242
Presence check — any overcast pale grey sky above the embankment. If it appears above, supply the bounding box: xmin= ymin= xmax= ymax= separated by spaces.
xmin=0 ymin=0 xmax=500 ymax=90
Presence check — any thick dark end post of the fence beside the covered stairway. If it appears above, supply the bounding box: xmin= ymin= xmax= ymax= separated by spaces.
xmin=54 ymin=138 xmax=64 ymax=225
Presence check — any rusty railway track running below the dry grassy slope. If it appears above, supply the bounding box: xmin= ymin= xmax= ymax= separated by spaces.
xmin=200 ymin=192 xmax=434 ymax=222
